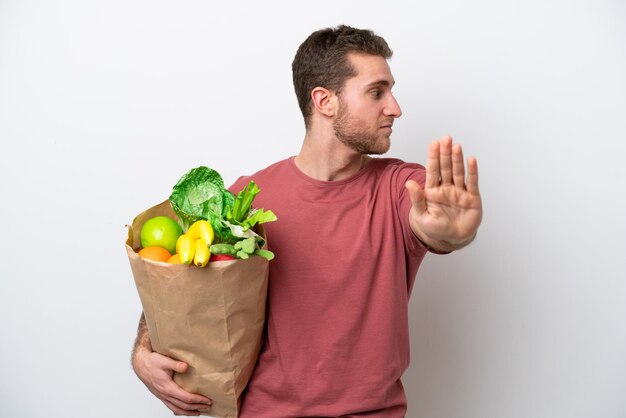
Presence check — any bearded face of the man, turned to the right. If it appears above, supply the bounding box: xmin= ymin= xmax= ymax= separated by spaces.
xmin=333 ymin=54 xmax=402 ymax=154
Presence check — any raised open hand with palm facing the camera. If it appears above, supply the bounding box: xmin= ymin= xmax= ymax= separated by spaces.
xmin=406 ymin=136 xmax=483 ymax=251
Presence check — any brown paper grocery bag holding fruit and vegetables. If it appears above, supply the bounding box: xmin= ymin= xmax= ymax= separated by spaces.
xmin=126 ymin=201 xmax=269 ymax=418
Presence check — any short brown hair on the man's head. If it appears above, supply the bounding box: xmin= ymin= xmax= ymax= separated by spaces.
xmin=291 ymin=25 xmax=393 ymax=127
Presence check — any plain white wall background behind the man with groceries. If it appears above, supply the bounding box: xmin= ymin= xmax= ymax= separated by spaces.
xmin=0 ymin=0 xmax=626 ymax=418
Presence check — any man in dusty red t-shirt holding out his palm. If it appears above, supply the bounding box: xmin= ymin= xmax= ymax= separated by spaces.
xmin=133 ymin=26 xmax=482 ymax=418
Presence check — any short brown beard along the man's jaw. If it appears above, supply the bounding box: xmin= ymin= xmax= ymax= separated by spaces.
xmin=333 ymin=102 xmax=391 ymax=154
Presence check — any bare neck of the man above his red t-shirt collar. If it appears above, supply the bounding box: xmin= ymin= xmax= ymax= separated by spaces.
xmin=295 ymin=133 xmax=371 ymax=181
